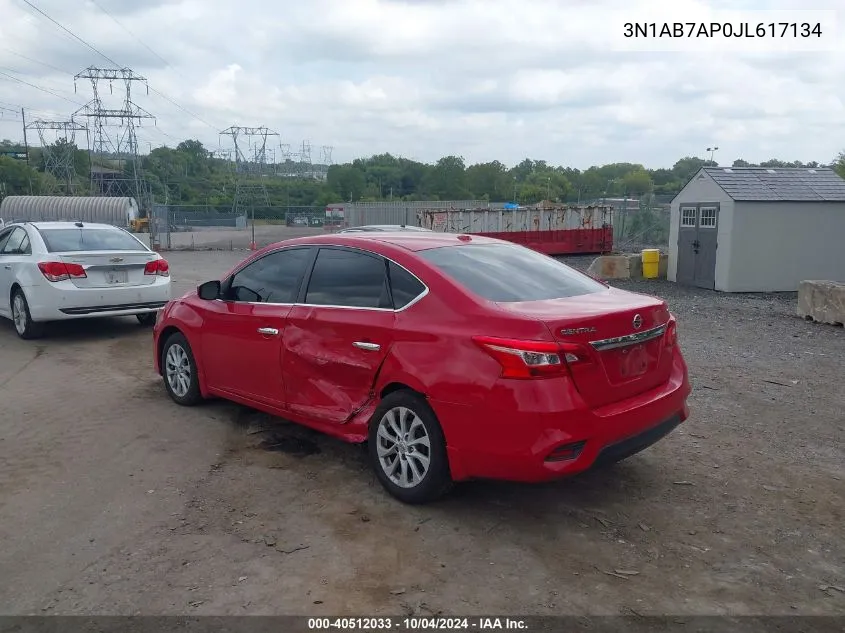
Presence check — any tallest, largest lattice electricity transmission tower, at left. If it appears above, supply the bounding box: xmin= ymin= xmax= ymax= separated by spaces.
xmin=73 ymin=66 xmax=156 ymax=235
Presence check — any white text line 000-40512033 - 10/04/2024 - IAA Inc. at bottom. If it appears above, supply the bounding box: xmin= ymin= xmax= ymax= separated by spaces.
xmin=308 ymin=617 xmax=528 ymax=631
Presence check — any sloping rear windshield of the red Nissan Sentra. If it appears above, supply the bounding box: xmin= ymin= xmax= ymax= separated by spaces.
xmin=419 ymin=244 xmax=606 ymax=302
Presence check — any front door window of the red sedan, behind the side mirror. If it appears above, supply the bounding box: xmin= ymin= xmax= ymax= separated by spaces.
xmin=226 ymin=248 xmax=311 ymax=303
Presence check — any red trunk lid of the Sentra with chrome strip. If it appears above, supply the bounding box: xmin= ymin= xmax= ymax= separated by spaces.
xmin=498 ymin=288 xmax=672 ymax=407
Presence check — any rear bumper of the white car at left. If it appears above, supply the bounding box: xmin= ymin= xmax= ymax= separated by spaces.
xmin=25 ymin=277 xmax=170 ymax=321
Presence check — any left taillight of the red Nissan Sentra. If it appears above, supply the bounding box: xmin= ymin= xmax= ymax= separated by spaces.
xmin=472 ymin=336 xmax=566 ymax=379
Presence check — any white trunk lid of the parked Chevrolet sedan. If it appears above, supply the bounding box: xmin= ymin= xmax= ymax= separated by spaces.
xmin=55 ymin=251 xmax=158 ymax=288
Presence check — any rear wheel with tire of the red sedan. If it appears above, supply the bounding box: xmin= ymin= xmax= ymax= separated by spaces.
xmin=368 ymin=390 xmax=452 ymax=504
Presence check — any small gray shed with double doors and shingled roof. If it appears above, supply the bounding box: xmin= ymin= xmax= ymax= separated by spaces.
xmin=668 ymin=167 xmax=845 ymax=292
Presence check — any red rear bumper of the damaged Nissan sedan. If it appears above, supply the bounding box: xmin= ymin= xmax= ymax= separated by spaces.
xmin=432 ymin=358 xmax=691 ymax=482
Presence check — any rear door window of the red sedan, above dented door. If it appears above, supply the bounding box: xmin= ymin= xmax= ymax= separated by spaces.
xmin=305 ymin=248 xmax=392 ymax=309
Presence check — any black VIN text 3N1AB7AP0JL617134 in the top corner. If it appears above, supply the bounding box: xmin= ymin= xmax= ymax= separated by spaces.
xmin=623 ymin=22 xmax=822 ymax=39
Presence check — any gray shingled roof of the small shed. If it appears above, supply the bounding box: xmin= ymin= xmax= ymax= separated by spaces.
xmin=702 ymin=167 xmax=845 ymax=202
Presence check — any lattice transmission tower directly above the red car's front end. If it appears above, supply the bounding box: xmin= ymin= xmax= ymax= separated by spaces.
xmin=220 ymin=125 xmax=279 ymax=249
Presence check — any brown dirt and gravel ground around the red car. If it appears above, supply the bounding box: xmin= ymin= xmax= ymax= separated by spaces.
xmin=0 ymin=252 xmax=845 ymax=615
